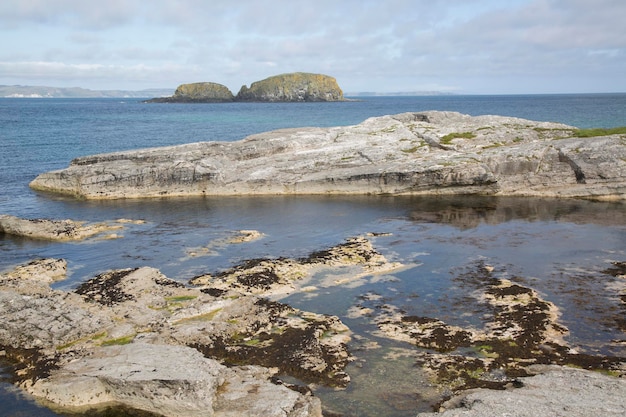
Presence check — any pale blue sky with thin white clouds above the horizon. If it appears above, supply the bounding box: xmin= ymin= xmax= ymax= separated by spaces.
xmin=0 ymin=0 xmax=626 ymax=94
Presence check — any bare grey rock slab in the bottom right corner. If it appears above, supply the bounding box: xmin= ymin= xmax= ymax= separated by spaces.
xmin=418 ymin=366 xmax=626 ymax=417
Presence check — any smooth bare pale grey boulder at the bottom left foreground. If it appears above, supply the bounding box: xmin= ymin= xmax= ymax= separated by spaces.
xmin=29 ymin=342 xmax=321 ymax=417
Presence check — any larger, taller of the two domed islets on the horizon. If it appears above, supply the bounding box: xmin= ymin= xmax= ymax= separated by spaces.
xmin=236 ymin=72 xmax=343 ymax=101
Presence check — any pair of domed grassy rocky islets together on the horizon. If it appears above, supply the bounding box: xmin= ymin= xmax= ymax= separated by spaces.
xmin=145 ymin=72 xmax=344 ymax=103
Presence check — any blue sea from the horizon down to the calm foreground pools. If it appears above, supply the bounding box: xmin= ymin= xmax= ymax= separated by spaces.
xmin=0 ymin=93 xmax=626 ymax=417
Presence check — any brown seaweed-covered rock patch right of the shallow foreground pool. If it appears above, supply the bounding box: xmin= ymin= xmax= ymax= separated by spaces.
xmin=361 ymin=262 xmax=626 ymax=391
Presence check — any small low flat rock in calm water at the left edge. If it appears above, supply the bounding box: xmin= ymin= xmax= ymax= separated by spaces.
xmin=0 ymin=215 xmax=131 ymax=241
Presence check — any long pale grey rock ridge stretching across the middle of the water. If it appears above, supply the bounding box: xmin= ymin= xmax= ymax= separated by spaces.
xmin=30 ymin=112 xmax=626 ymax=199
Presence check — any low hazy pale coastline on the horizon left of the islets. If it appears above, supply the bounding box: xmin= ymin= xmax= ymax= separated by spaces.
xmin=0 ymin=85 xmax=174 ymax=98
